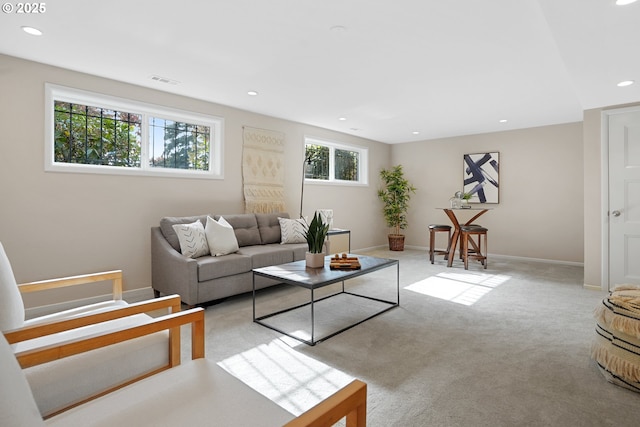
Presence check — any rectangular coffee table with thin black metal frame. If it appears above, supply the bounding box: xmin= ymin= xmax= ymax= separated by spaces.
xmin=253 ymin=255 xmax=400 ymax=345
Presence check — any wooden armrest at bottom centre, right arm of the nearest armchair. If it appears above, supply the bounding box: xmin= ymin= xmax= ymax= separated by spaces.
xmin=284 ymin=380 xmax=367 ymax=427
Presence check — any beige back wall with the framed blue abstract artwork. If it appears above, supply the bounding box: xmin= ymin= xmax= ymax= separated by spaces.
xmin=392 ymin=123 xmax=584 ymax=263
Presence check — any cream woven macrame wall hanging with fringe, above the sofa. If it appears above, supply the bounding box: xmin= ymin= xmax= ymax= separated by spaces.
xmin=242 ymin=126 xmax=286 ymax=213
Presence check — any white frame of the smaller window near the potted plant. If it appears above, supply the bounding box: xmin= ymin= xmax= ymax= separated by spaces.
xmin=302 ymin=136 xmax=369 ymax=186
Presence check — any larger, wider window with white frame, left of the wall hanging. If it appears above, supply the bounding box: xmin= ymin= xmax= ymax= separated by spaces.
xmin=45 ymin=85 xmax=223 ymax=178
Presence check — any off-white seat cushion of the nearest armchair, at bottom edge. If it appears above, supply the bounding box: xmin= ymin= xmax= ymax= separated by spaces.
xmin=45 ymin=359 xmax=294 ymax=427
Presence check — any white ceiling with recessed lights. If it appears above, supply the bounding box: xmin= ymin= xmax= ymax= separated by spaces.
xmin=0 ymin=0 xmax=640 ymax=143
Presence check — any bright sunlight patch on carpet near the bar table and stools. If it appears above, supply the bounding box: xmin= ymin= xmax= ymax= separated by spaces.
xmin=404 ymin=272 xmax=510 ymax=305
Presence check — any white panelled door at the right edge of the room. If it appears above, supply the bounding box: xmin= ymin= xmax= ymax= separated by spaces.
xmin=608 ymin=110 xmax=640 ymax=290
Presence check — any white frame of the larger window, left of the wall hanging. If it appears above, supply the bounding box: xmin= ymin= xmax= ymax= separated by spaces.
xmin=44 ymin=83 xmax=224 ymax=179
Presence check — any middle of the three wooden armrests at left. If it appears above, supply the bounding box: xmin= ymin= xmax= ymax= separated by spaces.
xmin=4 ymin=295 xmax=181 ymax=344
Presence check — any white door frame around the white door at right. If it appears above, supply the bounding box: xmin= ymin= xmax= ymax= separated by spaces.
xmin=600 ymin=106 xmax=640 ymax=291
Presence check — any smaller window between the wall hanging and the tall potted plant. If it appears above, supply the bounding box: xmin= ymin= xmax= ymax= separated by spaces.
xmin=304 ymin=138 xmax=368 ymax=184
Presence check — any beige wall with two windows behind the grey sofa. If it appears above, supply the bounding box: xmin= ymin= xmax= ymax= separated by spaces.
xmin=0 ymin=55 xmax=391 ymax=305
